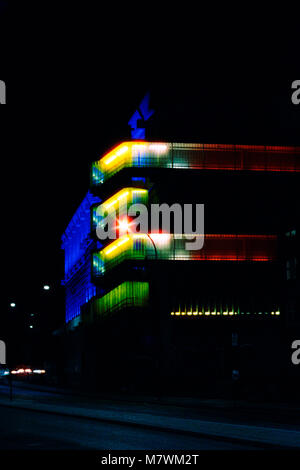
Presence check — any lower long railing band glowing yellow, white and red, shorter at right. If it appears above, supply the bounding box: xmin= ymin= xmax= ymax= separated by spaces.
xmin=92 ymin=234 xmax=277 ymax=278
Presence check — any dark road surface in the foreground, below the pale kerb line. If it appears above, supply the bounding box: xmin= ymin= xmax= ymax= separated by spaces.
xmin=0 ymin=406 xmax=253 ymax=450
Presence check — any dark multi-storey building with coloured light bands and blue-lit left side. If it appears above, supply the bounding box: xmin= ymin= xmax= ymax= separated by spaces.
xmin=63 ymin=140 xmax=300 ymax=392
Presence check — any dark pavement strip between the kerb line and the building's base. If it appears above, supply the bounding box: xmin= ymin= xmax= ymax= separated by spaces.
xmin=0 ymin=386 xmax=300 ymax=449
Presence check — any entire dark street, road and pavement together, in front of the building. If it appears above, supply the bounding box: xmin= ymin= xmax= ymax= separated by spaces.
xmin=0 ymin=381 xmax=300 ymax=450
